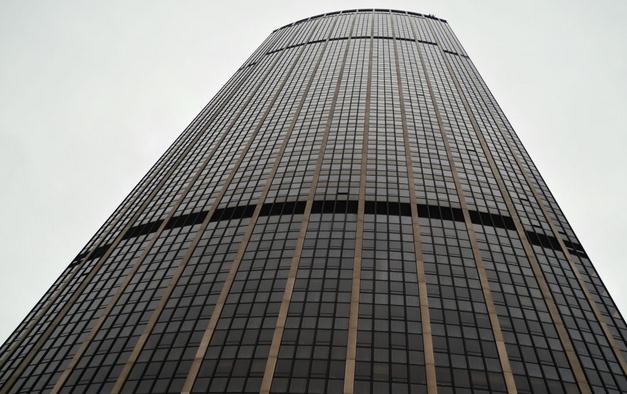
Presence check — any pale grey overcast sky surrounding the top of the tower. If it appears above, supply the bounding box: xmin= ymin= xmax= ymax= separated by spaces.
xmin=0 ymin=0 xmax=627 ymax=342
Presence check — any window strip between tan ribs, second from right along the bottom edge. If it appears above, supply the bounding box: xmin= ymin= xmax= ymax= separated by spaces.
xmin=418 ymin=19 xmax=592 ymax=393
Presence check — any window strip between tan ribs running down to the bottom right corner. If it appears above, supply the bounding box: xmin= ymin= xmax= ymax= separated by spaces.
xmin=446 ymin=39 xmax=625 ymax=390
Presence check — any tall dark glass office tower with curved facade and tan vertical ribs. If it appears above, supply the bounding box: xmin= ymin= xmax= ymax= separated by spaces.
xmin=0 ymin=9 xmax=627 ymax=394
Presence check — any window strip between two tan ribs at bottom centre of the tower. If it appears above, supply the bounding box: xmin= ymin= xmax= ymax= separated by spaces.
xmin=266 ymin=17 xmax=363 ymax=393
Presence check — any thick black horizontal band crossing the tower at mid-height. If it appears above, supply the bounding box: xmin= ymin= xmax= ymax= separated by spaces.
xmin=71 ymin=200 xmax=588 ymax=265
